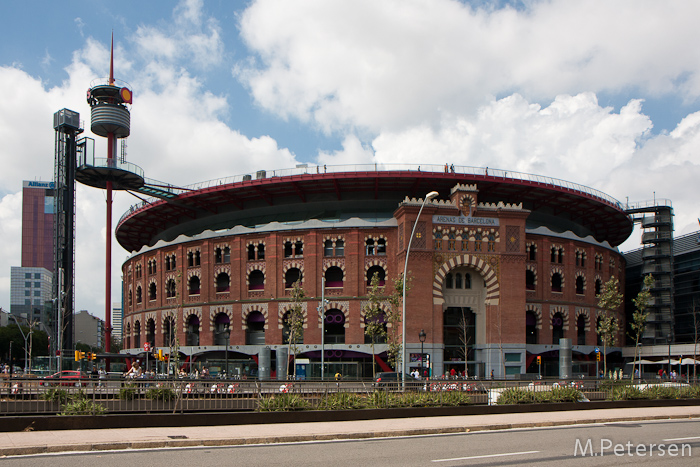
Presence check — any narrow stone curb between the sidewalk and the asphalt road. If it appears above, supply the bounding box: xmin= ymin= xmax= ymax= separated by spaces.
xmin=0 ymin=415 xmax=694 ymax=458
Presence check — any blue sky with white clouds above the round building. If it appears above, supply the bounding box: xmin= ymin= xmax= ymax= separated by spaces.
xmin=0 ymin=0 xmax=700 ymax=317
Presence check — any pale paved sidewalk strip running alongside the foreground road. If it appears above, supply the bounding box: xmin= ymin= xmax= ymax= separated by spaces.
xmin=0 ymin=406 xmax=700 ymax=457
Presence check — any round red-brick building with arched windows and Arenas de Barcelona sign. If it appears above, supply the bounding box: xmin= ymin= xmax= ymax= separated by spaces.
xmin=116 ymin=165 xmax=633 ymax=377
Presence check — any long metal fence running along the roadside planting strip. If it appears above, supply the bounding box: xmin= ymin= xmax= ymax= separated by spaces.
xmin=0 ymin=378 xmax=700 ymax=416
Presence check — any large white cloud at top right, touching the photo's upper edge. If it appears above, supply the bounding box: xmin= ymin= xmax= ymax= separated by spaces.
xmin=235 ymin=0 xmax=700 ymax=133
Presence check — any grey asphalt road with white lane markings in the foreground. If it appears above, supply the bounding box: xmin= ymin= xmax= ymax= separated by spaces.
xmin=0 ymin=419 xmax=700 ymax=467
